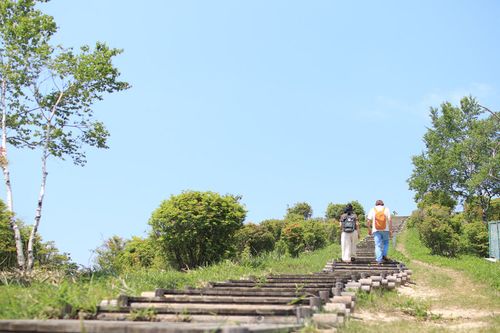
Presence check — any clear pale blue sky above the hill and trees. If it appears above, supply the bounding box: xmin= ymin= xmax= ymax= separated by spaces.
xmin=10 ymin=0 xmax=500 ymax=266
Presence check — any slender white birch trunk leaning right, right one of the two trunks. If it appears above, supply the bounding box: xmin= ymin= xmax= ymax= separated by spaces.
xmin=27 ymin=92 xmax=63 ymax=271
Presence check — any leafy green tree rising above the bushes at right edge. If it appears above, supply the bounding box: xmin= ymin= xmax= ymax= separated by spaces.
xmin=408 ymin=97 xmax=500 ymax=221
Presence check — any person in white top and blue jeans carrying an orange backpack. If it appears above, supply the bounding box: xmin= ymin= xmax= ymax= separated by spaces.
xmin=366 ymin=200 xmax=392 ymax=264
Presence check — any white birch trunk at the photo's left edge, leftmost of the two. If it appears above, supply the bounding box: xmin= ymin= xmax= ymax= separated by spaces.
xmin=0 ymin=80 xmax=26 ymax=270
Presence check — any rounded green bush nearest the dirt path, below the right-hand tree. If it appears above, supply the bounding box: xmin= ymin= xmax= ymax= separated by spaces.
xmin=416 ymin=205 xmax=461 ymax=256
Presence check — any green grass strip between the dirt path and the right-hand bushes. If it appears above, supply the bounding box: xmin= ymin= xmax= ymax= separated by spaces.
xmin=399 ymin=228 xmax=500 ymax=292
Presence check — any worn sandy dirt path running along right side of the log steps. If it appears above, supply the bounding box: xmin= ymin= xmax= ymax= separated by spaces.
xmin=348 ymin=232 xmax=500 ymax=332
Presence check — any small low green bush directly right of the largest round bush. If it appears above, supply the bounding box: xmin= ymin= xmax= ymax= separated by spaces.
xmin=235 ymin=223 xmax=275 ymax=256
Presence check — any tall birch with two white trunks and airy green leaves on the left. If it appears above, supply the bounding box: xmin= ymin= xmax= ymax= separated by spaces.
xmin=0 ymin=0 xmax=129 ymax=270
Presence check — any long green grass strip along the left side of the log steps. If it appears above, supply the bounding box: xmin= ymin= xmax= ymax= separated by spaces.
xmin=0 ymin=244 xmax=340 ymax=319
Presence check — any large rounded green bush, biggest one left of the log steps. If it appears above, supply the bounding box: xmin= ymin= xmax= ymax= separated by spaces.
xmin=149 ymin=191 xmax=246 ymax=269
